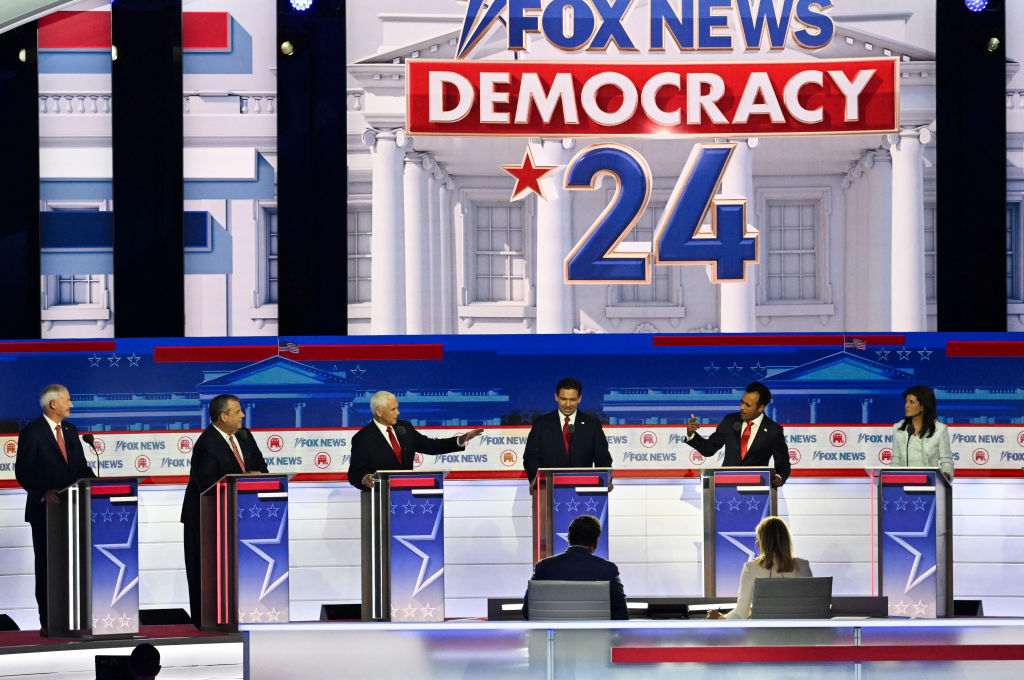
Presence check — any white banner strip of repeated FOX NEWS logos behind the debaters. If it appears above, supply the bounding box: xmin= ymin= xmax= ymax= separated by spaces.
xmin=0 ymin=425 xmax=1024 ymax=479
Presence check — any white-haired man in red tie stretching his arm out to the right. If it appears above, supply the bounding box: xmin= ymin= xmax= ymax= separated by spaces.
xmin=348 ymin=391 xmax=483 ymax=492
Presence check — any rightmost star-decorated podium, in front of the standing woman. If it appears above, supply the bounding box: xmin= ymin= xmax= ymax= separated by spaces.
xmin=877 ymin=468 xmax=953 ymax=619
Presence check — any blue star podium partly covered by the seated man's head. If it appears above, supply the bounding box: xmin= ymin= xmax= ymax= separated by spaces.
xmin=532 ymin=468 xmax=611 ymax=564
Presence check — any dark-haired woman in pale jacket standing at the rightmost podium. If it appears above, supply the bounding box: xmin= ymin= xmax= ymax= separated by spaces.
xmin=893 ymin=385 xmax=953 ymax=481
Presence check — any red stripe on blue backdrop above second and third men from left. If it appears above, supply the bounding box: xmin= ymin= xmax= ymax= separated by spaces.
xmin=153 ymin=344 xmax=444 ymax=364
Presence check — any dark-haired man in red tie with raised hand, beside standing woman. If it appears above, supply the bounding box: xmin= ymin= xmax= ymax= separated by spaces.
xmin=686 ymin=382 xmax=790 ymax=486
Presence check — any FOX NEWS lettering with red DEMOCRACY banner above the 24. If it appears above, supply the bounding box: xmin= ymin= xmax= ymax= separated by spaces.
xmin=408 ymin=0 xmax=899 ymax=137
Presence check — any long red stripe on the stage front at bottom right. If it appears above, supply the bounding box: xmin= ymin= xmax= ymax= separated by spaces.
xmin=611 ymin=644 xmax=1024 ymax=664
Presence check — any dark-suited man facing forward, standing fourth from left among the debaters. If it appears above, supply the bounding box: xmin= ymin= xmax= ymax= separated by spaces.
xmin=522 ymin=378 xmax=611 ymax=488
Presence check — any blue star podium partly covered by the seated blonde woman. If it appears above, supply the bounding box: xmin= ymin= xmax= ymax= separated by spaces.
xmin=700 ymin=467 xmax=778 ymax=597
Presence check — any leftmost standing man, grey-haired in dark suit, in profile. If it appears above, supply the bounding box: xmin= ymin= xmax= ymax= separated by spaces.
xmin=14 ymin=385 xmax=96 ymax=636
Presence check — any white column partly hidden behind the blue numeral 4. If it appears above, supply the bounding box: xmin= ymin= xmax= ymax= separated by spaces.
xmin=718 ymin=138 xmax=762 ymax=333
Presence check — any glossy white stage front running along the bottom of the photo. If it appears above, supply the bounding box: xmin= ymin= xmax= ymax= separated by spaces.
xmin=6 ymin=618 xmax=1024 ymax=680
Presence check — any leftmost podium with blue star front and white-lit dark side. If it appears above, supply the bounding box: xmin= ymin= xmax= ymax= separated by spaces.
xmin=46 ymin=477 xmax=138 ymax=639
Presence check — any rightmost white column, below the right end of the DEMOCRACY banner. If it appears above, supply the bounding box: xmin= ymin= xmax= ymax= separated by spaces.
xmin=888 ymin=128 xmax=932 ymax=331
